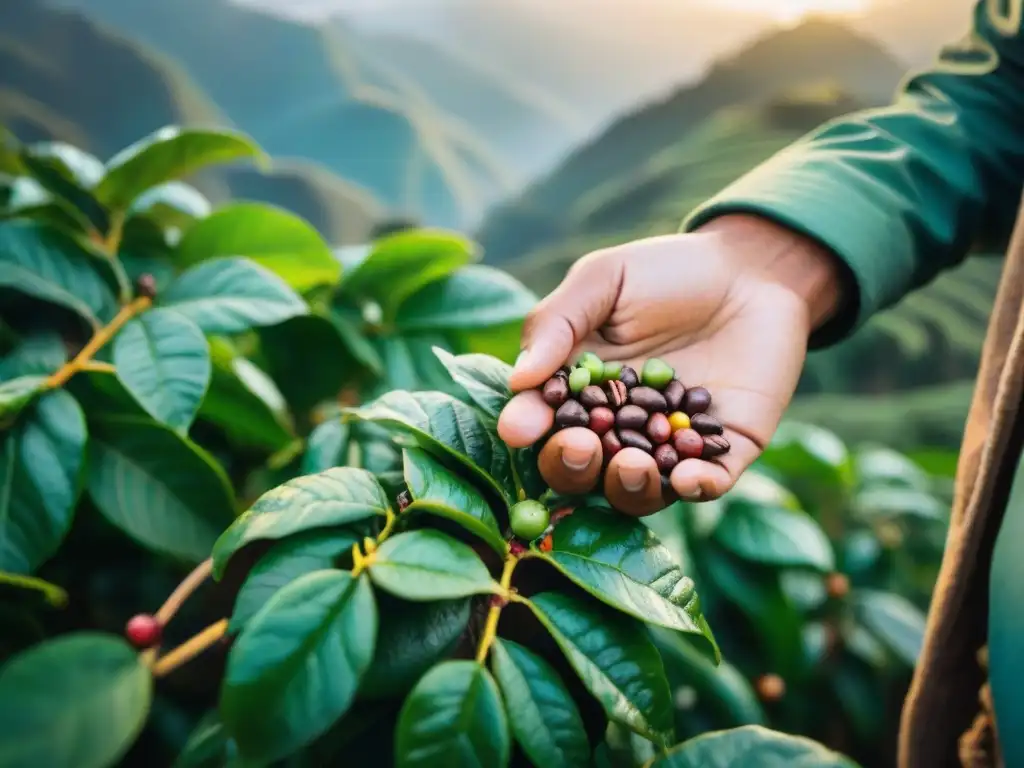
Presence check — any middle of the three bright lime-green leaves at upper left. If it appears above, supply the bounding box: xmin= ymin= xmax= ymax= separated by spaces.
xmin=175 ymin=203 xmax=341 ymax=292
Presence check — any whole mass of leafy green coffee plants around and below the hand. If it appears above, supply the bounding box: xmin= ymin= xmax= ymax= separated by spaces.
xmin=0 ymin=123 xmax=946 ymax=768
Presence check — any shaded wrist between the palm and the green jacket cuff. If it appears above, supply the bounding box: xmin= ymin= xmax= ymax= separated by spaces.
xmin=698 ymin=214 xmax=843 ymax=331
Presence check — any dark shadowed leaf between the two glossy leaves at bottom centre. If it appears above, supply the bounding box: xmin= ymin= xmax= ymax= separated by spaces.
xmin=359 ymin=592 xmax=472 ymax=700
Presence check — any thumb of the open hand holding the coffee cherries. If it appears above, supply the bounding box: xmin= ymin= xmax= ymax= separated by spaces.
xmin=509 ymin=251 xmax=623 ymax=391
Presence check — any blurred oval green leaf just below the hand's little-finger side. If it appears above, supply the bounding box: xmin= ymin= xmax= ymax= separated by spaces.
xmin=714 ymin=497 xmax=836 ymax=571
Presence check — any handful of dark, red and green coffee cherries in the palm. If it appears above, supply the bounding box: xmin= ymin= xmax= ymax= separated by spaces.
xmin=542 ymin=352 xmax=729 ymax=479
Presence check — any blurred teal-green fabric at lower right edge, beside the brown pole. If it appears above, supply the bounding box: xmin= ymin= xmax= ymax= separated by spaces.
xmin=988 ymin=450 xmax=1024 ymax=768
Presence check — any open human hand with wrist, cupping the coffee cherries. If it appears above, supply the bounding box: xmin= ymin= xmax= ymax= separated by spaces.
xmin=498 ymin=215 xmax=839 ymax=515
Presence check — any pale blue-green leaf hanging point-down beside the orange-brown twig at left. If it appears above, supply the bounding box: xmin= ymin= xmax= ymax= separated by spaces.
xmin=114 ymin=309 xmax=212 ymax=435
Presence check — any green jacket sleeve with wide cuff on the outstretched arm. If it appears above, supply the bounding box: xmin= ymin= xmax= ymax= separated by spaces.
xmin=683 ymin=0 xmax=1024 ymax=346
